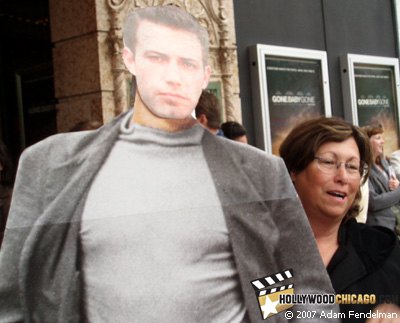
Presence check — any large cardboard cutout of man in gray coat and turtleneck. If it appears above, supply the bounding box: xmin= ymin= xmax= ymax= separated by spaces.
xmin=0 ymin=6 xmax=336 ymax=322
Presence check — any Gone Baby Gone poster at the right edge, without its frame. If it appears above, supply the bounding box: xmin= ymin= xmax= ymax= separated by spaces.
xmin=354 ymin=64 xmax=399 ymax=156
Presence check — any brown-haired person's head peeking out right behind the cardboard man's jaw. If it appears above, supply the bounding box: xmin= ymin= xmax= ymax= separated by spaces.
xmin=195 ymin=90 xmax=225 ymax=137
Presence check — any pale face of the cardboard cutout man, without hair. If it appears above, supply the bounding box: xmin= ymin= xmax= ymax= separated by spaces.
xmin=130 ymin=20 xmax=210 ymax=119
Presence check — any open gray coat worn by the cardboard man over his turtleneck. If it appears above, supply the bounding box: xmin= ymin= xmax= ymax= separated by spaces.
xmin=0 ymin=112 xmax=337 ymax=323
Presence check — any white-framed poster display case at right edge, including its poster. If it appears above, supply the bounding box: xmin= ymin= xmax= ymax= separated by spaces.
xmin=340 ymin=54 xmax=400 ymax=156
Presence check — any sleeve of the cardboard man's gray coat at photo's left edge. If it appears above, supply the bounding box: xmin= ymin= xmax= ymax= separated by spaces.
xmin=0 ymin=148 xmax=47 ymax=322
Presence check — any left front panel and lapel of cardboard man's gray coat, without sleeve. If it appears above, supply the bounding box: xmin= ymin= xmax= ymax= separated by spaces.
xmin=20 ymin=110 xmax=128 ymax=322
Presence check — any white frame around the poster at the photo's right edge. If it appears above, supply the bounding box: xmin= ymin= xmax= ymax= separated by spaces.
xmin=340 ymin=54 xmax=400 ymax=127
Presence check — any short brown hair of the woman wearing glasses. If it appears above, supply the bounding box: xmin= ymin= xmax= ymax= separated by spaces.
xmin=279 ymin=117 xmax=372 ymax=221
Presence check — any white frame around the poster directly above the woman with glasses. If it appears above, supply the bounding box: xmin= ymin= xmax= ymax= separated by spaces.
xmin=249 ymin=44 xmax=332 ymax=153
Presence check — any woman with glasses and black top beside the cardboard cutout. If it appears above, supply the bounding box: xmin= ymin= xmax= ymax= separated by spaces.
xmin=279 ymin=117 xmax=400 ymax=322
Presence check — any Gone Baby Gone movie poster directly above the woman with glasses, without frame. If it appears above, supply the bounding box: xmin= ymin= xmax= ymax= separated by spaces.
xmin=265 ymin=57 xmax=325 ymax=155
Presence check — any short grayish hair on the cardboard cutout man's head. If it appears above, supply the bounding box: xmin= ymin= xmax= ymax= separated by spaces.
xmin=123 ymin=5 xmax=208 ymax=66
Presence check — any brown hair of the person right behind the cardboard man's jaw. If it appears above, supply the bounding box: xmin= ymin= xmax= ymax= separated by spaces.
xmin=195 ymin=90 xmax=221 ymax=129
